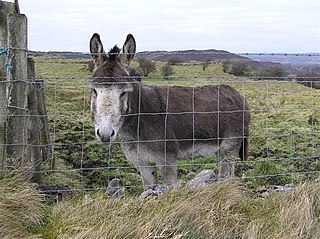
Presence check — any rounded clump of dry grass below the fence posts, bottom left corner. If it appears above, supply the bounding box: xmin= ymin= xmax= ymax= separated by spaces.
xmin=0 ymin=175 xmax=44 ymax=239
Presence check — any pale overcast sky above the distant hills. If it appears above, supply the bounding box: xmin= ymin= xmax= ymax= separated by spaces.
xmin=15 ymin=0 xmax=320 ymax=53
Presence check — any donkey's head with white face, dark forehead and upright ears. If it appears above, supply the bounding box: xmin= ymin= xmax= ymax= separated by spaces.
xmin=89 ymin=33 xmax=136 ymax=143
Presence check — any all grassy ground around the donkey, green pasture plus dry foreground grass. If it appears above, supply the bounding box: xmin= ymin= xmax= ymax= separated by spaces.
xmin=0 ymin=57 xmax=320 ymax=239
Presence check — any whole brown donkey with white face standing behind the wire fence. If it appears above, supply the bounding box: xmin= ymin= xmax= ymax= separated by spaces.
xmin=89 ymin=33 xmax=250 ymax=189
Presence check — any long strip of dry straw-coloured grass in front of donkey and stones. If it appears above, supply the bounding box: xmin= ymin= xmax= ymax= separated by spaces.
xmin=42 ymin=182 xmax=320 ymax=239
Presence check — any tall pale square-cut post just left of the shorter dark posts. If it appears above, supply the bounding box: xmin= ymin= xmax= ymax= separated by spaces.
xmin=7 ymin=13 xmax=30 ymax=169
